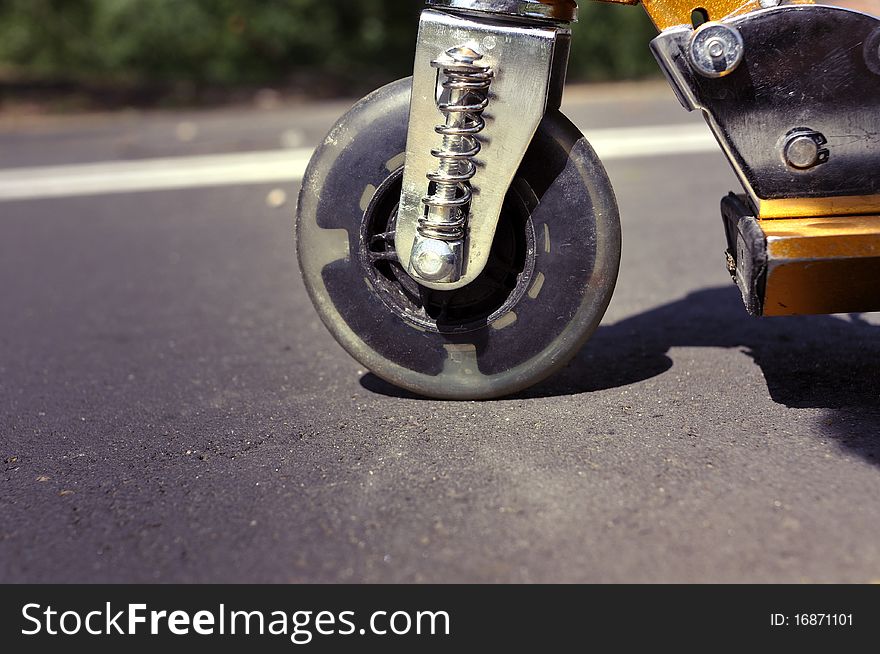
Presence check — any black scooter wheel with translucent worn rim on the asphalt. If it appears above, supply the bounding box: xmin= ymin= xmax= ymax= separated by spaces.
xmin=296 ymin=79 xmax=620 ymax=399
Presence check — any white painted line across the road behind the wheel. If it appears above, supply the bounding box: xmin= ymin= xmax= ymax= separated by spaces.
xmin=0 ymin=125 xmax=718 ymax=202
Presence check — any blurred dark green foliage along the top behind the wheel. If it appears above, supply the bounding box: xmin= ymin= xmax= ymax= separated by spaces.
xmin=0 ymin=0 xmax=656 ymax=95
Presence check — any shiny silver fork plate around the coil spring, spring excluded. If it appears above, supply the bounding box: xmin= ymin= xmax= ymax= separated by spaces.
xmin=395 ymin=9 xmax=570 ymax=290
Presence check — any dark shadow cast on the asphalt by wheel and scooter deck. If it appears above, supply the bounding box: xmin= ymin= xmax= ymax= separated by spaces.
xmin=361 ymin=285 xmax=880 ymax=463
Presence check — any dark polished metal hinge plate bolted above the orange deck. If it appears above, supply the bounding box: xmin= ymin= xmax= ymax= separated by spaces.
xmin=651 ymin=5 xmax=880 ymax=218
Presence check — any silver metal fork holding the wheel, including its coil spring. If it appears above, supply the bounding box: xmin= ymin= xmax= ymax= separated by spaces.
xmin=395 ymin=0 xmax=574 ymax=290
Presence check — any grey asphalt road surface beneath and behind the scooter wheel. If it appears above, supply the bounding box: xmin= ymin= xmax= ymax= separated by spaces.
xmin=0 ymin=86 xmax=880 ymax=582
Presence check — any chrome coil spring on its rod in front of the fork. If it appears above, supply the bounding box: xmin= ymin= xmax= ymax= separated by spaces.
xmin=418 ymin=47 xmax=492 ymax=241
